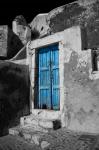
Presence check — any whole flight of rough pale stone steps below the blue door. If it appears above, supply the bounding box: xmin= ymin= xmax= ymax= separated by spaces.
xmin=9 ymin=111 xmax=61 ymax=145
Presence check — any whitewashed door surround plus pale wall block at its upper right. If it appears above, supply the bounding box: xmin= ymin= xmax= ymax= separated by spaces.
xmin=27 ymin=27 xmax=81 ymax=126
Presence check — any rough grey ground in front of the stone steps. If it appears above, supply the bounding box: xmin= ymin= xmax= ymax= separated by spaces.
xmin=0 ymin=129 xmax=99 ymax=150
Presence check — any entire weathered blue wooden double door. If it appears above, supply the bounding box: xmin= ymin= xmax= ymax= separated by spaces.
xmin=38 ymin=44 xmax=59 ymax=110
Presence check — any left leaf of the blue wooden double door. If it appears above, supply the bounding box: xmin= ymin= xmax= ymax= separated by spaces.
xmin=38 ymin=48 xmax=50 ymax=108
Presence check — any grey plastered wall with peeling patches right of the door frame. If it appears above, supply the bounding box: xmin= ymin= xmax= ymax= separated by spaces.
xmin=63 ymin=27 xmax=99 ymax=133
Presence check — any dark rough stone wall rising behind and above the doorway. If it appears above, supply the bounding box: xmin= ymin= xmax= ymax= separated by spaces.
xmin=30 ymin=0 xmax=99 ymax=49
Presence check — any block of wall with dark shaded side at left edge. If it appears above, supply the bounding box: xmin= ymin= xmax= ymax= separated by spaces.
xmin=0 ymin=25 xmax=24 ymax=59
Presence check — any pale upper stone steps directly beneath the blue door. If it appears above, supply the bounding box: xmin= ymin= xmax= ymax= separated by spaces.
xmin=20 ymin=109 xmax=60 ymax=128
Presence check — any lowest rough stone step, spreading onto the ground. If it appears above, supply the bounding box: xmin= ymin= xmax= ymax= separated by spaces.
xmin=9 ymin=125 xmax=48 ymax=145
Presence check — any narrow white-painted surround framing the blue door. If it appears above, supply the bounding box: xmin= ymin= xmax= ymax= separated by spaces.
xmin=27 ymin=29 xmax=64 ymax=119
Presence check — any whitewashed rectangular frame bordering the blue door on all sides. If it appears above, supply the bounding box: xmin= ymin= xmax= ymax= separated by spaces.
xmin=27 ymin=31 xmax=64 ymax=116
